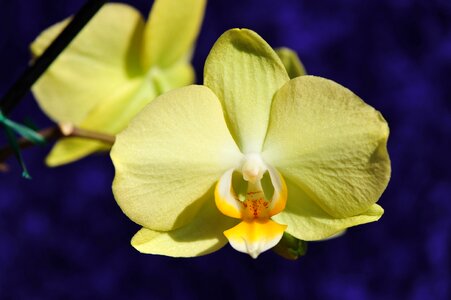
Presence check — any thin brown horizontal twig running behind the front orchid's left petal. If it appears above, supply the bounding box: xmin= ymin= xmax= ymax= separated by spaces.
xmin=0 ymin=123 xmax=116 ymax=172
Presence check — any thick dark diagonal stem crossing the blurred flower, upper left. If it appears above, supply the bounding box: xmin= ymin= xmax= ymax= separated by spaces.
xmin=0 ymin=0 xmax=107 ymax=115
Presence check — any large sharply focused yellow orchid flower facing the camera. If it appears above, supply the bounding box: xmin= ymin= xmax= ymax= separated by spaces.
xmin=111 ymin=29 xmax=390 ymax=258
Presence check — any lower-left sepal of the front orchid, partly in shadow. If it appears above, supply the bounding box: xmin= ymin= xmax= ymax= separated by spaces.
xmin=132 ymin=198 xmax=237 ymax=257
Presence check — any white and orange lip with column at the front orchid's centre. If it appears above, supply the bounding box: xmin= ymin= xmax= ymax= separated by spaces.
xmin=215 ymin=153 xmax=287 ymax=258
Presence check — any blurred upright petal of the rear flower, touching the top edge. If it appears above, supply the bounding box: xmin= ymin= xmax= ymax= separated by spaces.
xmin=141 ymin=0 xmax=206 ymax=69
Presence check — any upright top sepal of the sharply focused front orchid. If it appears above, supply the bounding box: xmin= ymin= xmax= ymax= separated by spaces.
xmin=204 ymin=29 xmax=289 ymax=154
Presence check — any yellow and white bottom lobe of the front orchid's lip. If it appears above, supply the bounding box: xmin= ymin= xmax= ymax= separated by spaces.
xmin=224 ymin=219 xmax=287 ymax=258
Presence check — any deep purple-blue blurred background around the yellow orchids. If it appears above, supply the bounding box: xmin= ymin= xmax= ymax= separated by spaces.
xmin=0 ymin=0 xmax=451 ymax=299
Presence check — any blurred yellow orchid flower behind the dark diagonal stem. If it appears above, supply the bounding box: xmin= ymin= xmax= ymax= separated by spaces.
xmin=31 ymin=0 xmax=206 ymax=166
